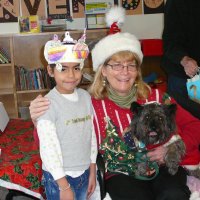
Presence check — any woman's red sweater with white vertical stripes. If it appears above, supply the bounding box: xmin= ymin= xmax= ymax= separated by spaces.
xmin=92 ymin=89 xmax=200 ymax=169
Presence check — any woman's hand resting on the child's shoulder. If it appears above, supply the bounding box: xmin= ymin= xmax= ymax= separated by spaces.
xmin=29 ymin=95 xmax=50 ymax=125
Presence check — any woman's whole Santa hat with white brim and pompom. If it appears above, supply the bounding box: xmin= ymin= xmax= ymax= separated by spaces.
xmin=92 ymin=7 xmax=143 ymax=71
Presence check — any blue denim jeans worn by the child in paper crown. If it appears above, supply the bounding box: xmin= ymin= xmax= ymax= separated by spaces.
xmin=43 ymin=169 xmax=89 ymax=200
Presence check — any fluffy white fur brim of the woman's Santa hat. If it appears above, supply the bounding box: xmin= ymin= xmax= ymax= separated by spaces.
xmin=92 ymin=33 xmax=143 ymax=71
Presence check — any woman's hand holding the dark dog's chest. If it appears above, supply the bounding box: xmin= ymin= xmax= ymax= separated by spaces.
xmin=147 ymin=146 xmax=167 ymax=165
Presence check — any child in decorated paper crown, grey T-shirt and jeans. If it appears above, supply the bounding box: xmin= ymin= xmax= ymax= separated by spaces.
xmin=37 ymin=32 xmax=97 ymax=200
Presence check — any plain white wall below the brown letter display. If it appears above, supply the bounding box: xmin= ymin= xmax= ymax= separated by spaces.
xmin=0 ymin=14 xmax=163 ymax=39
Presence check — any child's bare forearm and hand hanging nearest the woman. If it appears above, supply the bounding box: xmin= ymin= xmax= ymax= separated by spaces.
xmin=87 ymin=164 xmax=96 ymax=199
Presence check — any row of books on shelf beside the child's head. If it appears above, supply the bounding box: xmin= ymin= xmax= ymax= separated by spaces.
xmin=15 ymin=66 xmax=52 ymax=91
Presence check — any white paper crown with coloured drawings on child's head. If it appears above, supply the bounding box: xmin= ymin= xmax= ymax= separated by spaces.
xmin=44 ymin=29 xmax=89 ymax=71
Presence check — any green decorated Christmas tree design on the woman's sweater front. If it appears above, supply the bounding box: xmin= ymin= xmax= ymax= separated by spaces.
xmin=100 ymin=117 xmax=158 ymax=180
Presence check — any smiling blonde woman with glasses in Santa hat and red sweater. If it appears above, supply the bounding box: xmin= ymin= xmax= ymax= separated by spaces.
xmin=30 ymin=7 xmax=200 ymax=200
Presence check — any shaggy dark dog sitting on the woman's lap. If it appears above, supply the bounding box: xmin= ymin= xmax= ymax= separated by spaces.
xmin=130 ymin=102 xmax=185 ymax=175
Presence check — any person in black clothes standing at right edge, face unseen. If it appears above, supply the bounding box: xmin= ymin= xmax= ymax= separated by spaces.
xmin=161 ymin=0 xmax=200 ymax=119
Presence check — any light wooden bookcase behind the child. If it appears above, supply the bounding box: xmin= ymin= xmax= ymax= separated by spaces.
xmin=0 ymin=29 xmax=107 ymax=118
